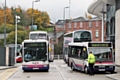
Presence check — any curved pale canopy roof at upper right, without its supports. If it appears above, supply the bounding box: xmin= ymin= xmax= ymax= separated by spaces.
xmin=88 ymin=0 xmax=115 ymax=17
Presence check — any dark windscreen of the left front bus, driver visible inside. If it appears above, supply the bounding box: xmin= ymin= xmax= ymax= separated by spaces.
xmin=24 ymin=43 xmax=47 ymax=62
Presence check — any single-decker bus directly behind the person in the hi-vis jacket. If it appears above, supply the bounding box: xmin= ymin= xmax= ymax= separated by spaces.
xmin=67 ymin=42 xmax=115 ymax=73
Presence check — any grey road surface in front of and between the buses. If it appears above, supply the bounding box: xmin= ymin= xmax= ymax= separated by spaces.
xmin=0 ymin=60 xmax=110 ymax=80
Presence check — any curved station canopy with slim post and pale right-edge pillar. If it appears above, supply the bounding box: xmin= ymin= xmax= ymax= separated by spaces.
xmin=88 ymin=0 xmax=120 ymax=66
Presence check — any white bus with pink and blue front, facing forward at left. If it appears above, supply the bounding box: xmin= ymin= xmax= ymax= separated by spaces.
xmin=22 ymin=39 xmax=49 ymax=71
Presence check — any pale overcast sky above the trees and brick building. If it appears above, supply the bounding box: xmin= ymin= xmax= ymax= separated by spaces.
xmin=0 ymin=0 xmax=94 ymax=22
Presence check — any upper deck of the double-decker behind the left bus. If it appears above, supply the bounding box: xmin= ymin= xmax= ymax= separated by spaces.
xmin=29 ymin=31 xmax=49 ymax=40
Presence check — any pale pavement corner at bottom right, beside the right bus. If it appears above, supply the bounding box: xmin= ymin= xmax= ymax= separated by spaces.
xmin=106 ymin=67 xmax=120 ymax=80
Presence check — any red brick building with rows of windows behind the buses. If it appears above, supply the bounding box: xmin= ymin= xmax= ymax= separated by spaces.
xmin=56 ymin=17 xmax=106 ymax=41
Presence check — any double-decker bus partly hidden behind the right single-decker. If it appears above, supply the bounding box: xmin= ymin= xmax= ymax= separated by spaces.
xmin=63 ymin=30 xmax=92 ymax=63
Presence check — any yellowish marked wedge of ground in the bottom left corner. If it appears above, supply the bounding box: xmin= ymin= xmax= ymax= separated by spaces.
xmin=0 ymin=68 xmax=19 ymax=80
